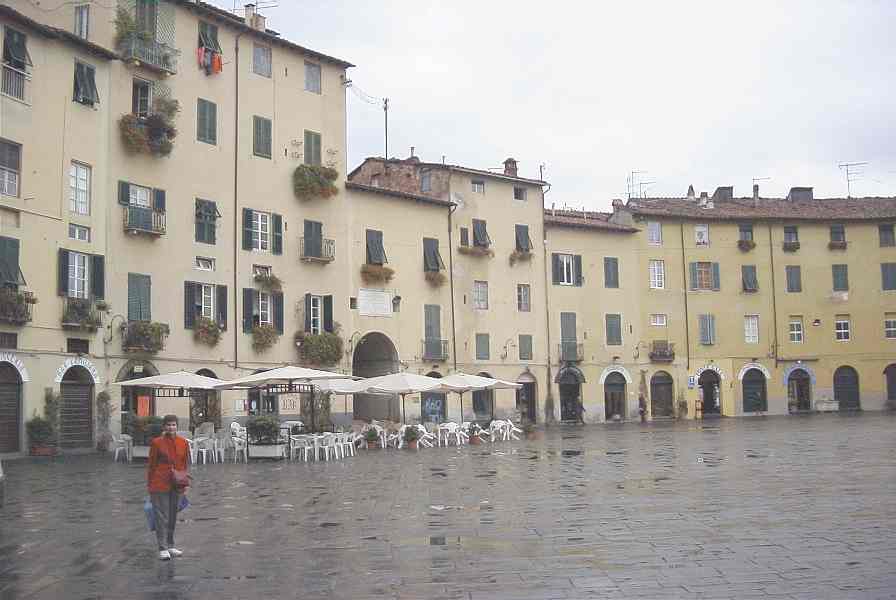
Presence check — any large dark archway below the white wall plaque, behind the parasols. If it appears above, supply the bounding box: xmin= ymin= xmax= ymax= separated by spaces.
xmin=352 ymin=332 xmax=401 ymax=421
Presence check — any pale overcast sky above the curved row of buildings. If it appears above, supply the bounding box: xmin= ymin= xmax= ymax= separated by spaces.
xmin=215 ymin=0 xmax=896 ymax=209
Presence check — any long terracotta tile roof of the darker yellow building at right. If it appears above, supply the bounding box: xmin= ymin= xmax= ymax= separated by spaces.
xmin=626 ymin=197 xmax=896 ymax=221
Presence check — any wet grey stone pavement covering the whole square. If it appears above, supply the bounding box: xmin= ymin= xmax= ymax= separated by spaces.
xmin=0 ymin=414 xmax=896 ymax=600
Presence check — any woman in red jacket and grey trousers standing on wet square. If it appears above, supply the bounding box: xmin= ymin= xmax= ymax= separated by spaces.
xmin=146 ymin=415 xmax=189 ymax=560
